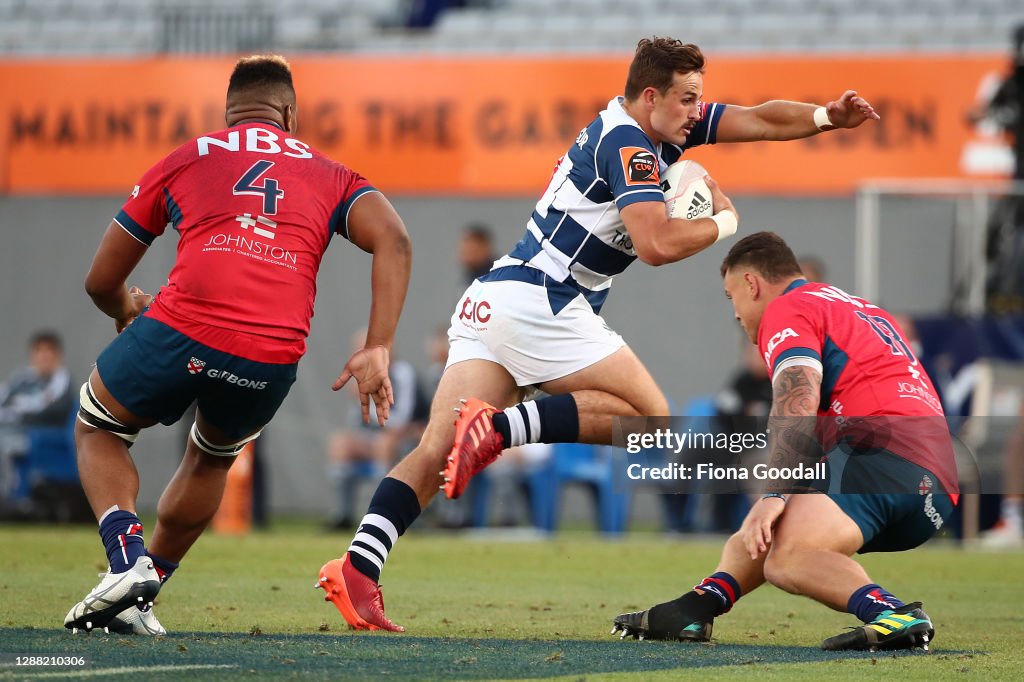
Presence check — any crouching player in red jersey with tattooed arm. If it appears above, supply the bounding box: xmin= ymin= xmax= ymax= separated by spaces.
xmin=612 ymin=232 xmax=957 ymax=649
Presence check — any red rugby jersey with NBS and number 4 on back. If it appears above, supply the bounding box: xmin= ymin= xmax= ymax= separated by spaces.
xmin=116 ymin=122 xmax=375 ymax=364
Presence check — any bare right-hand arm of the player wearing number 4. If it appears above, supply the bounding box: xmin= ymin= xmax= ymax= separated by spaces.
xmin=332 ymin=191 xmax=413 ymax=426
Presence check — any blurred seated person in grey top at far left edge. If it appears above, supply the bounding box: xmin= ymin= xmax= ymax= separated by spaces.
xmin=0 ymin=330 xmax=74 ymax=499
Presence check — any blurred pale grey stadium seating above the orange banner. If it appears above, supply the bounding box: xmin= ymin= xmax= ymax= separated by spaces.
xmin=0 ymin=0 xmax=1024 ymax=56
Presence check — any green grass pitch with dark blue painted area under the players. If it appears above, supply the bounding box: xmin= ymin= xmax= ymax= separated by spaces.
xmin=0 ymin=524 xmax=1024 ymax=681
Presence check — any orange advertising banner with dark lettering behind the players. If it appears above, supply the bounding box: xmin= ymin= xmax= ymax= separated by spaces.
xmin=0 ymin=54 xmax=1006 ymax=196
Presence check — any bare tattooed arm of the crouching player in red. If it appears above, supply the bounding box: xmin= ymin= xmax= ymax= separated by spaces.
xmin=768 ymin=366 xmax=823 ymax=493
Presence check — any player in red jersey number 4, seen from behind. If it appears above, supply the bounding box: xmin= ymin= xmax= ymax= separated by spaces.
xmin=65 ymin=55 xmax=412 ymax=634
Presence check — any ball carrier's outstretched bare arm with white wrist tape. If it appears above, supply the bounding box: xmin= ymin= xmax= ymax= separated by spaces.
xmin=717 ymin=90 xmax=880 ymax=142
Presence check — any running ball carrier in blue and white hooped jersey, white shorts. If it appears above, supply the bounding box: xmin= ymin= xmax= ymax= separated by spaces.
xmin=318 ymin=38 xmax=879 ymax=631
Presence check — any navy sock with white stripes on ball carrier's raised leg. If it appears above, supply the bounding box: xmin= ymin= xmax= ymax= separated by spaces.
xmin=490 ymin=393 xmax=580 ymax=447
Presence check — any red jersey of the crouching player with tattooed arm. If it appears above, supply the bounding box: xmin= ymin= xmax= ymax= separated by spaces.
xmin=758 ymin=280 xmax=957 ymax=493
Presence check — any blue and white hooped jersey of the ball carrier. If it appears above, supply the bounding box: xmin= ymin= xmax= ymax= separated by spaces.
xmin=481 ymin=97 xmax=726 ymax=313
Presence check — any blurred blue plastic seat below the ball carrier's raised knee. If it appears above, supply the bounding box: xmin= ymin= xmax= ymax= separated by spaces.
xmin=528 ymin=442 xmax=630 ymax=534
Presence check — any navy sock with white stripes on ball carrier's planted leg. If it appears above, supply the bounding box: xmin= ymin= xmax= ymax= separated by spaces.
xmin=348 ymin=477 xmax=420 ymax=583
